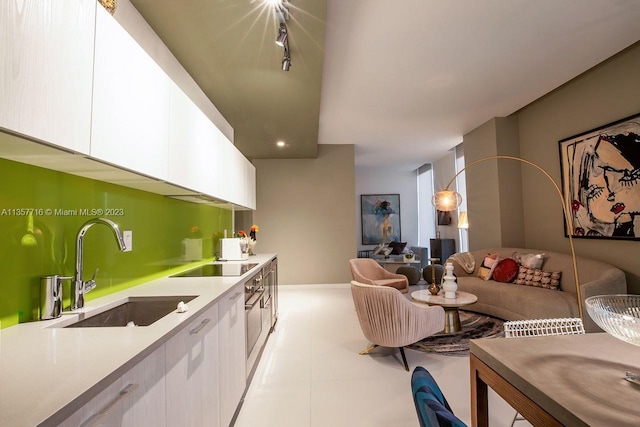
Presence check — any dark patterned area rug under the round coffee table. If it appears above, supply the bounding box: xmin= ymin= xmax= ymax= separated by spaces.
xmin=407 ymin=310 xmax=504 ymax=356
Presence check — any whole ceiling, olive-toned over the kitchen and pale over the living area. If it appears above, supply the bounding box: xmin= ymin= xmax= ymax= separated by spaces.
xmin=131 ymin=0 xmax=640 ymax=170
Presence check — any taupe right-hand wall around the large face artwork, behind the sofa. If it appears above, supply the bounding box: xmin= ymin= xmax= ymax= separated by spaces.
xmin=518 ymin=42 xmax=640 ymax=293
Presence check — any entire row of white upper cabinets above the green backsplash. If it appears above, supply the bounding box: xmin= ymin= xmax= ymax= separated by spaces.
xmin=0 ymin=0 xmax=255 ymax=209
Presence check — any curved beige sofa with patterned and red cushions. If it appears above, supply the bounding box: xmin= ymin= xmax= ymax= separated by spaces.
xmin=447 ymin=248 xmax=627 ymax=332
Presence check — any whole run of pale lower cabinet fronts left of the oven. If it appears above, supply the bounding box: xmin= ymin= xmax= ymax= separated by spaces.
xmin=61 ymin=290 xmax=247 ymax=427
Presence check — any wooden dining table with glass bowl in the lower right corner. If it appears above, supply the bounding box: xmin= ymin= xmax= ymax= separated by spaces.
xmin=469 ymin=332 xmax=640 ymax=427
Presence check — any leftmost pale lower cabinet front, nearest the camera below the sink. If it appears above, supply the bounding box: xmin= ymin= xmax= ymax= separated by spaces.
xmin=60 ymin=346 xmax=168 ymax=427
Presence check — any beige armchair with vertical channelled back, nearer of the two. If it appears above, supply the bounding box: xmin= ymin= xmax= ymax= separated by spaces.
xmin=351 ymin=280 xmax=444 ymax=371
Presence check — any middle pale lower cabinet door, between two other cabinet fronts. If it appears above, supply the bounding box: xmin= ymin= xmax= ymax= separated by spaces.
xmin=165 ymin=304 xmax=220 ymax=427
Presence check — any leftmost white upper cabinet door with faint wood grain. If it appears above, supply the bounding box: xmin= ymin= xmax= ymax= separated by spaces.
xmin=0 ymin=0 xmax=97 ymax=154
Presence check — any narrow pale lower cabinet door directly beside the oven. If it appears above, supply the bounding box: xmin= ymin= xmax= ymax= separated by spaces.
xmin=218 ymin=283 xmax=247 ymax=426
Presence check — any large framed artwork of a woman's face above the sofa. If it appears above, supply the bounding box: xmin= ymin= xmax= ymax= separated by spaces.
xmin=559 ymin=114 xmax=640 ymax=240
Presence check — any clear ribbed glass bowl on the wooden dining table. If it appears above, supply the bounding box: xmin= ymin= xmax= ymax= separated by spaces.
xmin=585 ymin=294 xmax=640 ymax=346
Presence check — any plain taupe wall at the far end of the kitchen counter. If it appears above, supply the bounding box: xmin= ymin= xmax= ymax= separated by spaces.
xmin=253 ymin=145 xmax=358 ymax=285
